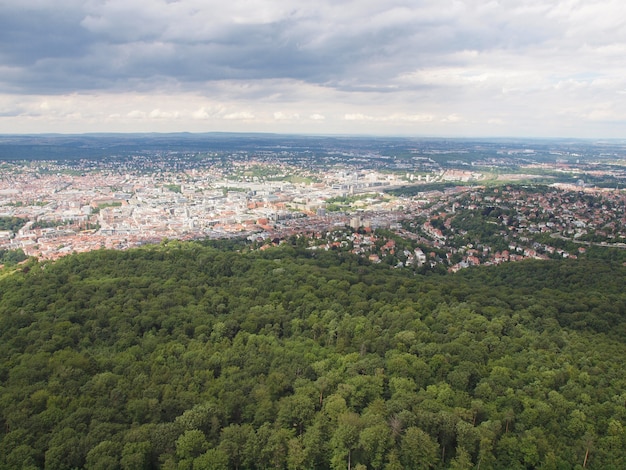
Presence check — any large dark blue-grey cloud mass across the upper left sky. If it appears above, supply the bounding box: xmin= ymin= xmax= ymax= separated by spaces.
xmin=0 ymin=0 xmax=576 ymax=92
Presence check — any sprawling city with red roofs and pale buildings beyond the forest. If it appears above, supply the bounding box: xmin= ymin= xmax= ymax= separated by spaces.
xmin=0 ymin=136 xmax=626 ymax=271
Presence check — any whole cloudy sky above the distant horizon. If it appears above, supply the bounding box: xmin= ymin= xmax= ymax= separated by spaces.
xmin=0 ymin=0 xmax=626 ymax=138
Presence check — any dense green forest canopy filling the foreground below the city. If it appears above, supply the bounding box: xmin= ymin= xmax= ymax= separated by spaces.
xmin=0 ymin=241 xmax=626 ymax=470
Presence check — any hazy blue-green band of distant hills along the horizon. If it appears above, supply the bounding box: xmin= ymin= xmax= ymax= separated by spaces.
xmin=0 ymin=132 xmax=626 ymax=163
